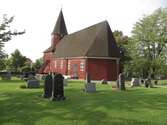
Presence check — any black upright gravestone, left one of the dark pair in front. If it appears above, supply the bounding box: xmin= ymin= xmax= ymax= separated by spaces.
xmin=43 ymin=74 xmax=53 ymax=98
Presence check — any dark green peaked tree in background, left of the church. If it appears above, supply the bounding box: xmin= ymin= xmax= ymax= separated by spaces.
xmin=10 ymin=49 xmax=26 ymax=72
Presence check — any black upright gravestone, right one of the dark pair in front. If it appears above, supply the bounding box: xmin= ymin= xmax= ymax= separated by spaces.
xmin=51 ymin=74 xmax=65 ymax=101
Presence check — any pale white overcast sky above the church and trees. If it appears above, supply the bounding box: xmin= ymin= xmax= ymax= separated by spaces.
xmin=0 ymin=0 xmax=167 ymax=61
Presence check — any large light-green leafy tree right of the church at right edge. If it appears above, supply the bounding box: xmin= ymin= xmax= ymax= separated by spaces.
xmin=128 ymin=8 xmax=167 ymax=78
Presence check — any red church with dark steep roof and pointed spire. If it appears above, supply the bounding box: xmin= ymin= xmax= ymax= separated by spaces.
xmin=40 ymin=10 xmax=120 ymax=80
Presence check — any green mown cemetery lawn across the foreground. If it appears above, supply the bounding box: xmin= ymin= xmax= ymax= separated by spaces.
xmin=0 ymin=78 xmax=167 ymax=125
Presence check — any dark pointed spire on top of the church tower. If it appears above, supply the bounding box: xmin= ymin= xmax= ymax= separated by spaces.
xmin=52 ymin=9 xmax=68 ymax=37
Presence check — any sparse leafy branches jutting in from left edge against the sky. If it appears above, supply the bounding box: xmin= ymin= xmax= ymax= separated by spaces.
xmin=0 ymin=15 xmax=25 ymax=59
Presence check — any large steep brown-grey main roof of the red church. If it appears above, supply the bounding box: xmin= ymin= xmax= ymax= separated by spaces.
xmin=55 ymin=21 xmax=120 ymax=58
